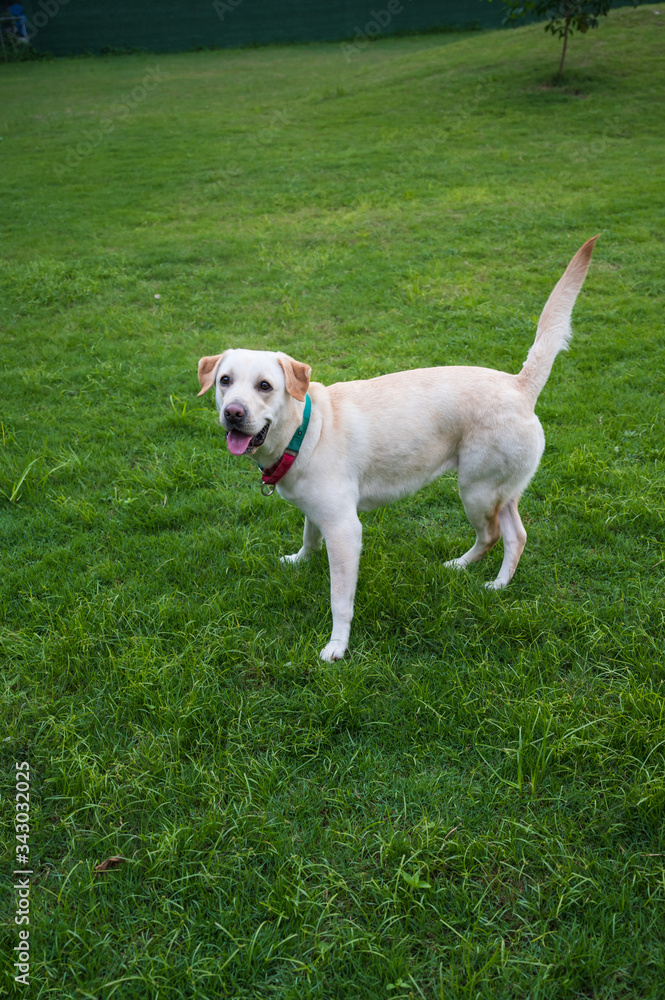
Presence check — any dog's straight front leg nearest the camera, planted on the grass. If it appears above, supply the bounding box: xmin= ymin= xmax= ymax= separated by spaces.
xmin=321 ymin=511 xmax=362 ymax=662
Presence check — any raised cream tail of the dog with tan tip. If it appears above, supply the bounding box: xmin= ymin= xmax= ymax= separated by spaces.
xmin=517 ymin=236 xmax=598 ymax=404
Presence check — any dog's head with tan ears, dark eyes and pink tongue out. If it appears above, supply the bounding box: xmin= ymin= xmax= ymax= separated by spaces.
xmin=199 ymin=350 xmax=311 ymax=455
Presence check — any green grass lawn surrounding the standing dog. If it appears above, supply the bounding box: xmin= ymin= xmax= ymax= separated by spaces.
xmin=0 ymin=7 xmax=665 ymax=1000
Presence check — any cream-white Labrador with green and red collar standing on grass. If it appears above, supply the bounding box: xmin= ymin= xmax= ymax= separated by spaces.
xmin=199 ymin=237 xmax=597 ymax=660
